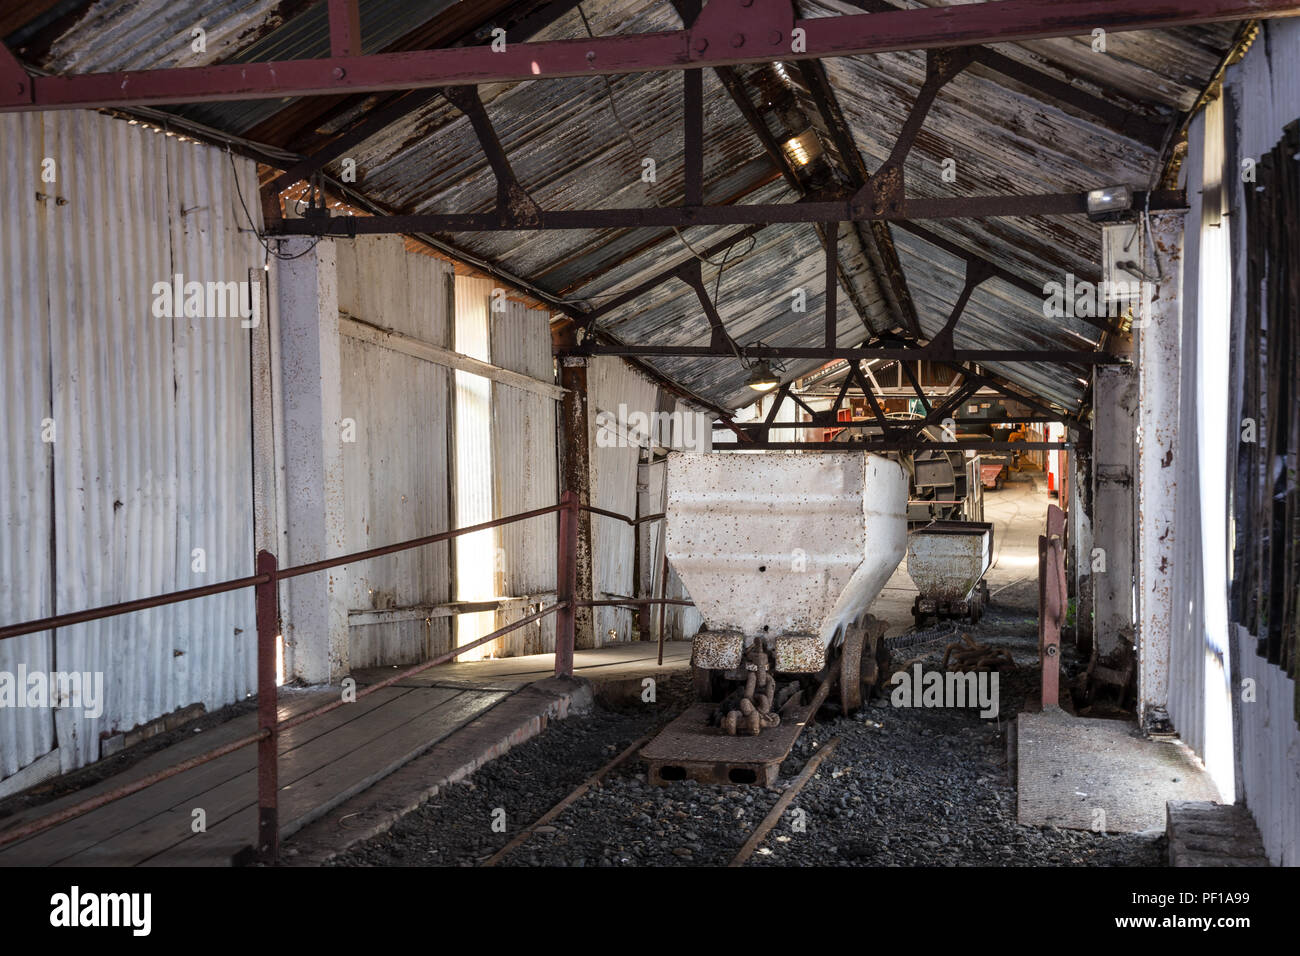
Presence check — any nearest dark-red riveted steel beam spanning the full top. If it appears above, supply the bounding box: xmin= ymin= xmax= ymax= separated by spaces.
xmin=0 ymin=0 xmax=1300 ymax=111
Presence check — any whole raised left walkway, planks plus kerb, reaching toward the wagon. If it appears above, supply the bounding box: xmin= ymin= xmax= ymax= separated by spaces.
xmin=0 ymin=641 xmax=690 ymax=866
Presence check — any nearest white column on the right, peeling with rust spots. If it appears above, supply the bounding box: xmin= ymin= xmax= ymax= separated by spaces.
xmin=1135 ymin=212 xmax=1183 ymax=732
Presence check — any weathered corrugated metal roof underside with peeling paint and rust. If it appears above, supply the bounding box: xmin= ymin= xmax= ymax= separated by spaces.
xmin=10 ymin=0 xmax=1236 ymax=407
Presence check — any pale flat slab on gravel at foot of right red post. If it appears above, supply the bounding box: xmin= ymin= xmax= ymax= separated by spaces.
xmin=1015 ymin=709 xmax=1218 ymax=832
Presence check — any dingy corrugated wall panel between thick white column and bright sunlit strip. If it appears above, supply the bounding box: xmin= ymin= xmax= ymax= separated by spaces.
xmin=335 ymin=237 xmax=451 ymax=667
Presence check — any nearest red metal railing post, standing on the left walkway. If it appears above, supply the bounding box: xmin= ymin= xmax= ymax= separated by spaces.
xmin=256 ymin=550 xmax=280 ymax=862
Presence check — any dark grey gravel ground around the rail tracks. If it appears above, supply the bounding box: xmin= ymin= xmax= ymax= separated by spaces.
xmin=319 ymin=600 xmax=1165 ymax=866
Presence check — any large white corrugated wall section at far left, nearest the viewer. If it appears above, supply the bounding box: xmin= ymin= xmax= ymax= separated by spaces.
xmin=0 ymin=112 xmax=263 ymax=775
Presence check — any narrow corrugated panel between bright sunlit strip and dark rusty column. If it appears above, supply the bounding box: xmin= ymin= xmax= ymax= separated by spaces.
xmin=489 ymin=300 xmax=559 ymax=656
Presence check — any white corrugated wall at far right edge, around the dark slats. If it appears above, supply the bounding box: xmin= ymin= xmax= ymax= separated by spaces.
xmin=1225 ymin=20 xmax=1300 ymax=866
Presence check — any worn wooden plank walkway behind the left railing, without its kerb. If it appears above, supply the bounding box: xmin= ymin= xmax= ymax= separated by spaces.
xmin=0 ymin=687 xmax=508 ymax=866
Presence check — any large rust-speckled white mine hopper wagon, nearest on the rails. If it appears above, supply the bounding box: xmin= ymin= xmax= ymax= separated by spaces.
xmin=666 ymin=451 xmax=907 ymax=717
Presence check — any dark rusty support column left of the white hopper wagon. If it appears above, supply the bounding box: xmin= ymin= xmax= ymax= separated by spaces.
xmin=560 ymin=330 xmax=595 ymax=648
